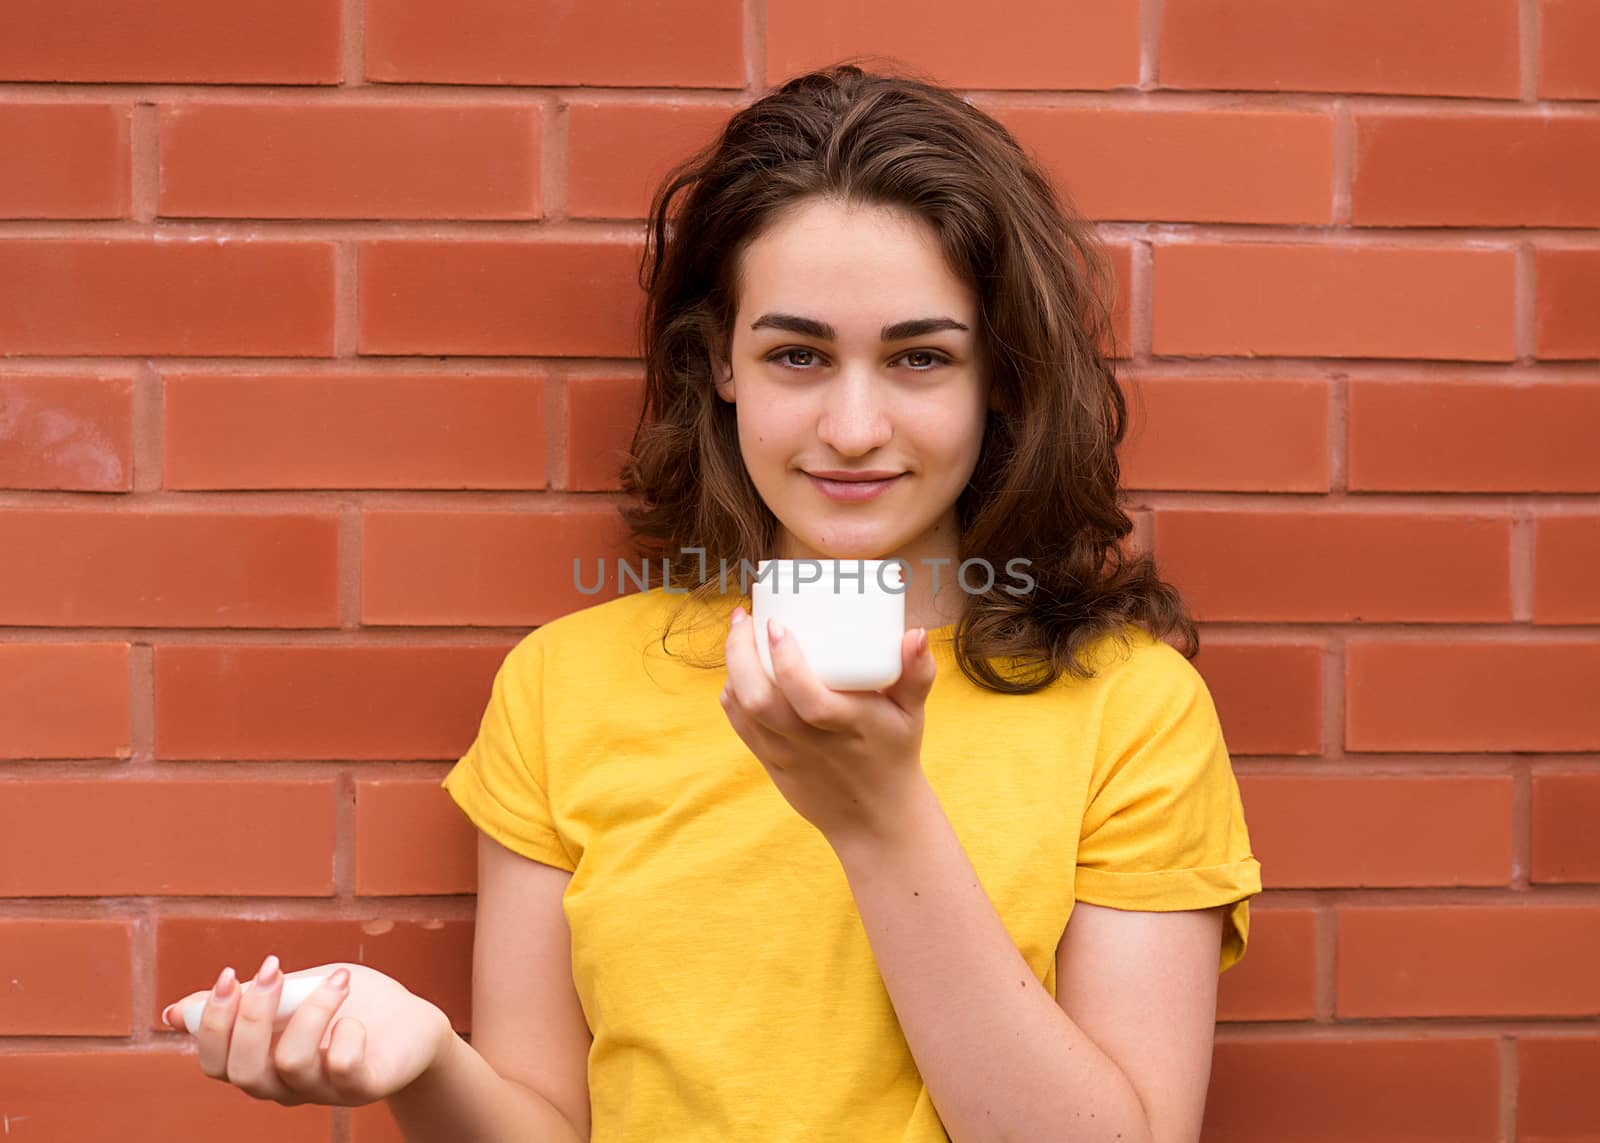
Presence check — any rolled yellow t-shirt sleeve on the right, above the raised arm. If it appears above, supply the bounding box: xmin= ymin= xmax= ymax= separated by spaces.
xmin=1075 ymin=640 xmax=1261 ymax=972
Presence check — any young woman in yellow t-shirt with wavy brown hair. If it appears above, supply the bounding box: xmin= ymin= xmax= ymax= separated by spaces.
xmin=162 ymin=66 xmax=1261 ymax=1143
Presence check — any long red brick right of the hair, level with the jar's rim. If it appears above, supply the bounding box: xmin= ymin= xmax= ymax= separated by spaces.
xmin=1155 ymin=509 xmax=1512 ymax=623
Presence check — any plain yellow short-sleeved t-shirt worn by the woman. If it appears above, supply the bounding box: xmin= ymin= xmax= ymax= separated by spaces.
xmin=443 ymin=588 xmax=1261 ymax=1143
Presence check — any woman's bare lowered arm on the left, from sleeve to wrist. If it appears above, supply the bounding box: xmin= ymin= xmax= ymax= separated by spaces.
xmin=389 ymin=831 xmax=592 ymax=1143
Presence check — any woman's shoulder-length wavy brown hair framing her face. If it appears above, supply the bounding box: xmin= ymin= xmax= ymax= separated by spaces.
xmin=619 ymin=62 xmax=1200 ymax=693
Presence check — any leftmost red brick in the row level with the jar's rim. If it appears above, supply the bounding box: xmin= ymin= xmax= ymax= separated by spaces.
xmin=0 ymin=507 xmax=339 ymax=628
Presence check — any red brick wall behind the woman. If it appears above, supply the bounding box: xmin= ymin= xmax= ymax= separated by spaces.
xmin=0 ymin=0 xmax=1600 ymax=1143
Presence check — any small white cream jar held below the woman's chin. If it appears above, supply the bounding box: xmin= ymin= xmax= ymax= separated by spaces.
xmin=750 ymin=559 xmax=906 ymax=690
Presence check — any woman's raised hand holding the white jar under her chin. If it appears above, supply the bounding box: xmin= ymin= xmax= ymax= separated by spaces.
xmin=722 ymin=607 xmax=936 ymax=847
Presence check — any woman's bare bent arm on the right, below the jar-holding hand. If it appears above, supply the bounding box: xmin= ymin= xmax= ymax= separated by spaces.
xmin=834 ymin=783 xmax=1221 ymax=1143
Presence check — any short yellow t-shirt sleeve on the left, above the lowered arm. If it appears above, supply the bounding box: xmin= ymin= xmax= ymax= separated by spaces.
xmin=440 ymin=631 xmax=576 ymax=871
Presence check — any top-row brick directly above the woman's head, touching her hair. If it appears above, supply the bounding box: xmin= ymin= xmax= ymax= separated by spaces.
xmin=766 ymin=0 xmax=1139 ymax=91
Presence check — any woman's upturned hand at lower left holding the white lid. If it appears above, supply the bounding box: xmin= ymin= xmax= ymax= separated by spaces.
xmin=162 ymin=956 xmax=454 ymax=1108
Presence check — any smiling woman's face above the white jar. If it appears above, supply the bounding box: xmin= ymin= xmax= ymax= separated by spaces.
xmin=717 ymin=199 xmax=989 ymax=575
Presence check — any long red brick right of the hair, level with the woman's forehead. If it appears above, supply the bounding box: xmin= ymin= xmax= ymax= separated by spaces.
xmin=1152 ymin=242 xmax=1515 ymax=362
